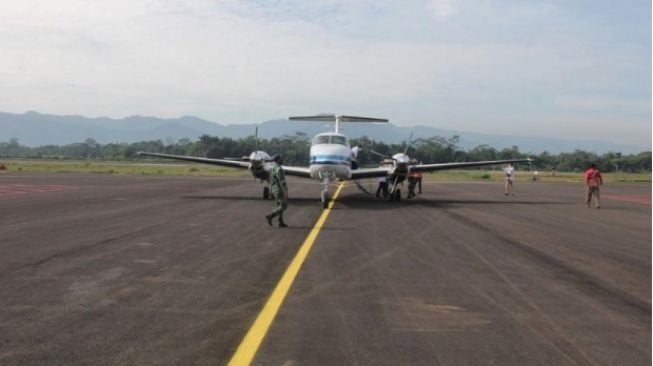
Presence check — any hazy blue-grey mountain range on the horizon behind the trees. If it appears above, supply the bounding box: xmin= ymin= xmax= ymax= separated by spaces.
xmin=0 ymin=112 xmax=650 ymax=154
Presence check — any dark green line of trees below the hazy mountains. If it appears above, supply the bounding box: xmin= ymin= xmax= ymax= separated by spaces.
xmin=0 ymin=132 xmax=651 ymax=173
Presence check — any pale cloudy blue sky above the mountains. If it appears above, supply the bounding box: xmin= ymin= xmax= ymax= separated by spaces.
xmin=0 ymin=0 xmax=652 ymax=149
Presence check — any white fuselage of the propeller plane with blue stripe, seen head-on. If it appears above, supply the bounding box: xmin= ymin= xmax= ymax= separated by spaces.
xmin=310 ymin=132 xmax=351 ymax=181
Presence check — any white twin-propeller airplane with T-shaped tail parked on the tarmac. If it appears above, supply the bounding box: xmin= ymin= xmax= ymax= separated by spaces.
xmin=138 ymin=114 xmax=532 ymax=208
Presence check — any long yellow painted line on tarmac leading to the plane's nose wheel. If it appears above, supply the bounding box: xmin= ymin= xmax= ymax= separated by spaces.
xmin=229 ymin=183 xmax=344 ymax=366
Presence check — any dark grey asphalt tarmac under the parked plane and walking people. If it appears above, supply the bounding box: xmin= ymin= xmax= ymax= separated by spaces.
xmin=0 ymin=173 xmax=651 ymax=365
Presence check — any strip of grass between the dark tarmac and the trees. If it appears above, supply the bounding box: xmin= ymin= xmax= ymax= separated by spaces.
xmin=0 ymin=159 xmax=651 ymax=183
